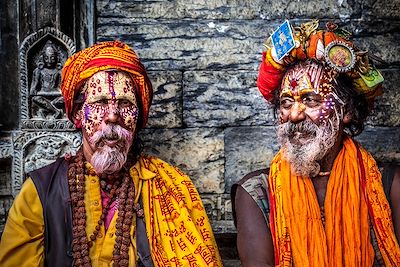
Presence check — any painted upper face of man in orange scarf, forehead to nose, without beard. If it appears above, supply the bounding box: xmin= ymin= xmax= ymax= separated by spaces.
xmin=280 ymin=62 xmax=340 ymax=124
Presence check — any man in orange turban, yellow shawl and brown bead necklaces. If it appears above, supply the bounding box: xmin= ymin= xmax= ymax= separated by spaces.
xmin=0 ymin=41 xmax=222 ymax=267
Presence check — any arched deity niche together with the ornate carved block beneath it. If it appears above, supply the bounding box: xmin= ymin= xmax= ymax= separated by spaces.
xmin=11 ymin=27 xmax=81 ymax=196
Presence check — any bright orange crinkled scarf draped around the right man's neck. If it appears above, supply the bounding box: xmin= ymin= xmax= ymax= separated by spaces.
xmin=268 ymin=137 xmax=400 ymax=267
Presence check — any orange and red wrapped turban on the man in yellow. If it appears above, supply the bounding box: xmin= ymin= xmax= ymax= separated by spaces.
xmin=61 ymin=41 xmax=153 ymax=131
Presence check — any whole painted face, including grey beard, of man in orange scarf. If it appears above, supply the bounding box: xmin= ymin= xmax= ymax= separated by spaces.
xmin=277 ymin=62 xmax=342 ymax=177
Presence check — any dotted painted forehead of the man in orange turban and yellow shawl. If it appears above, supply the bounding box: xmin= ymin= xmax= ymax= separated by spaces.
xmin=84 ymin=71 xmax=136 ymax=103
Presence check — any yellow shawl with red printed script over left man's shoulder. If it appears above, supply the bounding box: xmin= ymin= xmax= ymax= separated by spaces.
xmin=131 ymin=157 xmax=222 ymax=267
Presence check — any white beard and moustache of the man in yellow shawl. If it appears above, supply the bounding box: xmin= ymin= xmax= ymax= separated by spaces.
xmin=90 ymin=125 xmax=133 ymax=174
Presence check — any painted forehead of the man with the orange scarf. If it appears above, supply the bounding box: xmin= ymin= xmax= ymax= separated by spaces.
xmin=280 ymin=62 xmax=335 ymax=97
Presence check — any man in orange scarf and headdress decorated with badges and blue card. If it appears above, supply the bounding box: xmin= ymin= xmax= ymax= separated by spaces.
xmin=232 ymin=21 xmax=400 ymax=267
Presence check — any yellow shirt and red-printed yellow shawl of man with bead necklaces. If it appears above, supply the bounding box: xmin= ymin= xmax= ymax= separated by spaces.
xmin=0 ymin=156 xmax=222 ymax=267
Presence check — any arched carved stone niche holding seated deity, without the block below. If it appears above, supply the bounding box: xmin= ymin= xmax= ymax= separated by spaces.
xmin=20 ymin=27 xmax=75 ymax=130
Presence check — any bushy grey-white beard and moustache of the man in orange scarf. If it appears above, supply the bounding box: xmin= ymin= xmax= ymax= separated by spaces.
xmin=277 ymin=110 xmax=341 ymax=177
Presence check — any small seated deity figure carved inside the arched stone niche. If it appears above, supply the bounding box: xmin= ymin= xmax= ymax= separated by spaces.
xmin=30 ymin=40 xmax=63 ymax=119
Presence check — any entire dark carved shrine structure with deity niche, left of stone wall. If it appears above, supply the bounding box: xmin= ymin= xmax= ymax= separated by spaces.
xmin=0 ymin=0 xmax=96 ymax=235
